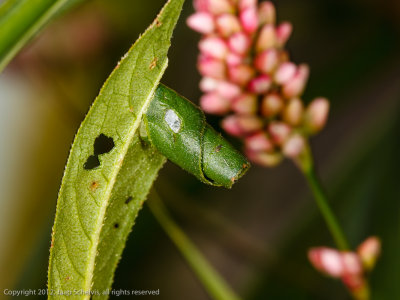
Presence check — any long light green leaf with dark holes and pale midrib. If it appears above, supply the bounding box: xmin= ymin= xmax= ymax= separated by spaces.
xmin=48 ymin=0 xmax=184 ymax=299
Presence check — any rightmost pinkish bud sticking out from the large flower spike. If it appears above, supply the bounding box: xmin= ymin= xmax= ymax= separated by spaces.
xmin=305 ymin=98 xmax=329 ymax=133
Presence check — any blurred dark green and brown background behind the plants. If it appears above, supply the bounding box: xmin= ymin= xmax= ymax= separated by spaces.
xmin=0 ymin=0 xmax=400 ymax=300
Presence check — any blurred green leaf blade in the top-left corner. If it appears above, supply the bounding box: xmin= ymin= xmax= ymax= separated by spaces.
xmin=0 ymin=0 xmax=81 ymax=72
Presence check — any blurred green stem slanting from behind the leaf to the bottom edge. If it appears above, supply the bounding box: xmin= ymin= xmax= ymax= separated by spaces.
xmin=147 ymin=190 xmax=240 ymax=300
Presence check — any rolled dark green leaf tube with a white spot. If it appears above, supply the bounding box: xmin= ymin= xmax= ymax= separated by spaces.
xmin=142 ymin=84 xmax=250 ymax=188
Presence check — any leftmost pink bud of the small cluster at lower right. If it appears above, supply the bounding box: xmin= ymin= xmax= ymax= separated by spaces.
xmin=308 ymin=247 xmax=344 ymax=278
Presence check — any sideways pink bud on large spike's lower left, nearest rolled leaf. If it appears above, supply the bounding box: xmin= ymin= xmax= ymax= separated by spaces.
xmin=222 ymin=115 xmax=263 ymax=137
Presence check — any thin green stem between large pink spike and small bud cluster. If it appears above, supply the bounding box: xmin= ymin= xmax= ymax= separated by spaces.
xmin=297 ymin=148 xmax=350 ymax=251
